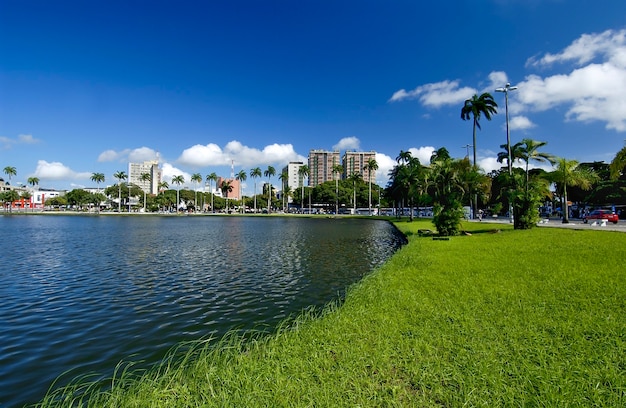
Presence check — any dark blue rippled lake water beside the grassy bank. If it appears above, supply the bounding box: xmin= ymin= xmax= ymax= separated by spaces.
xmin=0 ymin=215 xmax=404 ymax=407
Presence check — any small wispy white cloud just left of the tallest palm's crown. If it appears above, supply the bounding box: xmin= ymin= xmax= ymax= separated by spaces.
xmin=389 ymin=80 xmax=478 ymax=108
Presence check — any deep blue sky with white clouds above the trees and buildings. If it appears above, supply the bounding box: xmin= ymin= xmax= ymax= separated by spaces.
xmin=0 ymin=0 xmax=626 ymax=194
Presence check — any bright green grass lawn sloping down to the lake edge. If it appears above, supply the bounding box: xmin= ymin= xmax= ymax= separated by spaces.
xmin=40 ymin=221 xmax=626 ymax=407
